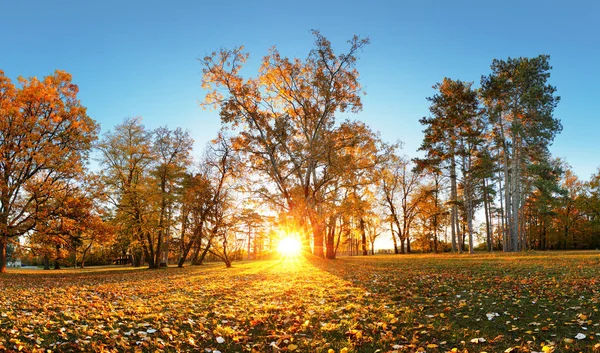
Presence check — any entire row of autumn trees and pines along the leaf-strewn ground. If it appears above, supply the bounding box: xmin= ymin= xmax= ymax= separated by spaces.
xmin=0 ymin=31 xmax=600 ymax=272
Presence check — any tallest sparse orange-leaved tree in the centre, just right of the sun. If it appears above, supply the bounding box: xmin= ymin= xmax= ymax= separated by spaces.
xmin=202 ymin=31 xmax=368 ymax=257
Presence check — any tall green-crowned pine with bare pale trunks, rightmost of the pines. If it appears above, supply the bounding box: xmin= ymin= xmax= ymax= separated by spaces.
xmin=481 ymin=55 xmax=562 ymax=251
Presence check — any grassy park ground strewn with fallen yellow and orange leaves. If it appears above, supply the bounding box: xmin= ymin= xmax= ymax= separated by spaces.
xmin=0 ymin=252 xmax=600 ymax=353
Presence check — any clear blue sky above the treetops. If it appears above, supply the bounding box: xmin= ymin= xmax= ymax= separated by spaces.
xmin=0 ymin=0 xmax=600 ymax=180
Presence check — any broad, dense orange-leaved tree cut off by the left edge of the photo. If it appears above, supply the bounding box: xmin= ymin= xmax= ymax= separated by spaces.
xmin=0 ymin=71 xmax=98 ymax=272
